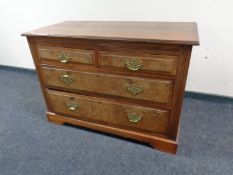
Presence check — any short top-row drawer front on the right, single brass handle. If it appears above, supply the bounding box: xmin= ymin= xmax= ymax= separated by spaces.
xmin=100 ymin=52 xmax=177 ymax=75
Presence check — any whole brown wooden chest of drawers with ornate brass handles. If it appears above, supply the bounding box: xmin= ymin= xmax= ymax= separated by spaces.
xmin=23 ymin=21 xmax=199 ymax=153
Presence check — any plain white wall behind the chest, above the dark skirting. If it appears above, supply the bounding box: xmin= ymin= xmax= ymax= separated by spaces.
xmin=0 ymin=0 xmax=233 ymax=97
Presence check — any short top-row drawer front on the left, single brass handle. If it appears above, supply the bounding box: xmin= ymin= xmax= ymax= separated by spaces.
xmin=38 ymin=47 xmax=94 ymax=64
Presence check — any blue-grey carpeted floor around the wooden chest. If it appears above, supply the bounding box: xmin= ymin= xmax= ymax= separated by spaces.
xmin=0 ymin=67 xmax=233 ymax=175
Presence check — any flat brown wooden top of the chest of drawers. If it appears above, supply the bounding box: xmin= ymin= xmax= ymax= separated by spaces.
xmin=23 ymin=21 xmax=199 ymax=45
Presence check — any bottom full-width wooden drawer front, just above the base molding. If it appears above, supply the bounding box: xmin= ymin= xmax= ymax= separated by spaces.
xmin=47 ymin=91 xmax=169 ymax=133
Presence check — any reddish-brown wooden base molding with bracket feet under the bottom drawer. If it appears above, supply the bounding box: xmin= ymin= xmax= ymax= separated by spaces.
xmin=47 ymin=112 xmax=178 ymax=154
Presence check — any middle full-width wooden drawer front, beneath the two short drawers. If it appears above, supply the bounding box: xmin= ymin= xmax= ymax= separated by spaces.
xmin=41 ymin=68 xmax=172 ymax=103
